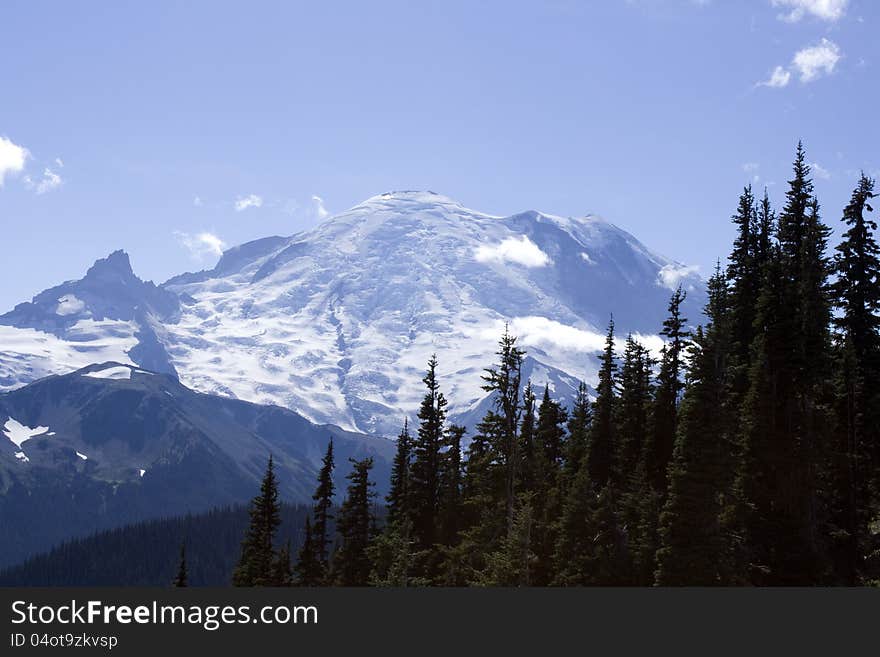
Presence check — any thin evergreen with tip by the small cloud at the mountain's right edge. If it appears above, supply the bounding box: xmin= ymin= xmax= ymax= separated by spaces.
xmin=646 ymin=286 xmax=688 ymax=497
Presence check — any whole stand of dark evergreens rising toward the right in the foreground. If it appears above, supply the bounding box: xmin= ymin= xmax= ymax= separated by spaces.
xmin=233 ymin=144 xmax=880 ymax=586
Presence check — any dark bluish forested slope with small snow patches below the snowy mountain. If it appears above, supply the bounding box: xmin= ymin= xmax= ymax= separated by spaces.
xmin=0 ymin=363 xmax=393 ymax=565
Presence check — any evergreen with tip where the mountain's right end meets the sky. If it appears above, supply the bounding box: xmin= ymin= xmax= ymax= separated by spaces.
xmin=657 ymin=271 xmax=731 ymax=586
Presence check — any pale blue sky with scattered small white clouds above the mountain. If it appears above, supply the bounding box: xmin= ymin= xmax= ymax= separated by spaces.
xmin=0 ymin=0 xmax=880 ymax=310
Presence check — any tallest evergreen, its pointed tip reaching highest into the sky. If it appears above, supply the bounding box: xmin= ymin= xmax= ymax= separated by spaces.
xmin=726 ymin=144 xmax=831 ymax=585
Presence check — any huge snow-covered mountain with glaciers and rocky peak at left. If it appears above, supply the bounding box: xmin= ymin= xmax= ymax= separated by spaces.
xmin=0 ymin=192 xmax=704 ymax=435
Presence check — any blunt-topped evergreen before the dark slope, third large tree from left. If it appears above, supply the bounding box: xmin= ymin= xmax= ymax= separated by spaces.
xmin=333 ymin=457 xmax=375 ymax=586
